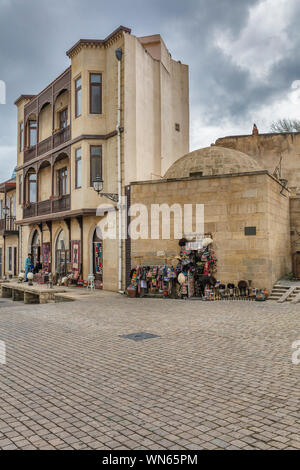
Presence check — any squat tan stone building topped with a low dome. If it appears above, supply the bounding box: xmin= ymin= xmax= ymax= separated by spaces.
xmin=127 ymin=145 xmax=291 ymax=289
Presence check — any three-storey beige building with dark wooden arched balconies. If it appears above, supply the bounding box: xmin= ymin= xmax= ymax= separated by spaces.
xmin=15 ymin=26 xmax=189 ymax=290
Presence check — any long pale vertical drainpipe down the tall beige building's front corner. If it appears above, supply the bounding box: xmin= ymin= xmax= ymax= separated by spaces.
xmin=116 ymin=48 xmax=124 ymax=294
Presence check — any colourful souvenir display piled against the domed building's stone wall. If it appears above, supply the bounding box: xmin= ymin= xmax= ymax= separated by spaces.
xmin=127 ymin=234 xmax=268 ymax=301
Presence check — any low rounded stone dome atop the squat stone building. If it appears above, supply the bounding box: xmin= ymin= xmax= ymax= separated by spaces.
xmin=164 ymin=145 xmax=262 ymax=179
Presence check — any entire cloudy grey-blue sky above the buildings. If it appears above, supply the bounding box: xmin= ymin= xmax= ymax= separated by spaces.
xmin=0 ymin=0 xmax=300 ymax=180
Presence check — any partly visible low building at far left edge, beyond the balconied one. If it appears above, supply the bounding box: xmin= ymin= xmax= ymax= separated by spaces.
xmin=0 ymin=175 xmax=19 ymax=278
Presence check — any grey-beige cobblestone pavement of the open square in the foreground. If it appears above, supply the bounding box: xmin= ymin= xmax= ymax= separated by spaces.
xmin=0 ymin=293 xmax=300 ymax=450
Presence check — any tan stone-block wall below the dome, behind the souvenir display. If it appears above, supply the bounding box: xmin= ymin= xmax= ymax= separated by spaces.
xmin=131 ymin=172 xmax=291 ymax=289
